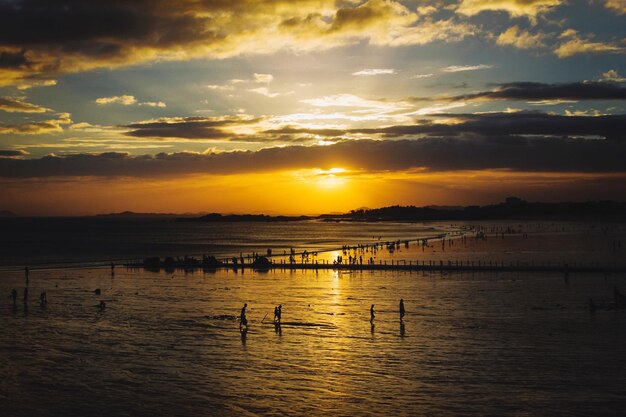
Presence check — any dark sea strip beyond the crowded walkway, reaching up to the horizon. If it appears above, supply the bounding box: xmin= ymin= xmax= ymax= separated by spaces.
xmin=0 ymin=217 xmax=456 ymax=267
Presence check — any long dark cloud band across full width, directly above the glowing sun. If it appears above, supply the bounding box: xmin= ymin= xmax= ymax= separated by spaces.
xmin=0 ymin=134 xmax=626 ymax=178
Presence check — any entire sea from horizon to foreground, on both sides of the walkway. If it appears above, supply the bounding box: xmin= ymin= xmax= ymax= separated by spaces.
xmin=0 ymin=219 xmax=626 ymax=417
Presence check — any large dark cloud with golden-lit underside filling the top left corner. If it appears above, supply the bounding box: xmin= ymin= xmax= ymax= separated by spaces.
xmin=0 ymin=0 xmax=479 ymax=88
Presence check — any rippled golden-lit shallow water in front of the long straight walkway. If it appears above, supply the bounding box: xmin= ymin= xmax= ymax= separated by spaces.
xmin=0 ymin=268 xmax=626 ymax=417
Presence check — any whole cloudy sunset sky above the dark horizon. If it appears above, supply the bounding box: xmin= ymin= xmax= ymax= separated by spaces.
xmin=0 ymin=0 xmax=626 ymax=216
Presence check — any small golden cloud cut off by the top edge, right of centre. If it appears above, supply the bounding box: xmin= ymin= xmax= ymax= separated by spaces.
xmin=456 ymin=0 xmax=564 ymax=20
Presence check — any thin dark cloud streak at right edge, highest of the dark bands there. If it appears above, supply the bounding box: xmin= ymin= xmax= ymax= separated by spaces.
xmin=414 ymin=81 xmax=626 ymax=101
